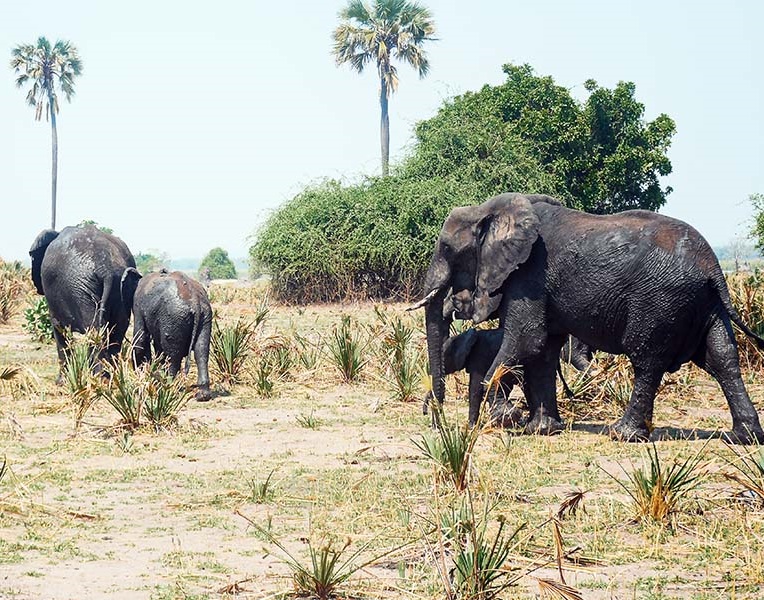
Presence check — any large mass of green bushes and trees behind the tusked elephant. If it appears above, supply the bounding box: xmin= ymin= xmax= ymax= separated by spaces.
xmin=250 ymin=65 xmax=674 ymax=303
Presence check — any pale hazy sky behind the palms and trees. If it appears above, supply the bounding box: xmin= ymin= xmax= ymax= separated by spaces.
xmin=0 ymin=0 xmax=764 ymax=259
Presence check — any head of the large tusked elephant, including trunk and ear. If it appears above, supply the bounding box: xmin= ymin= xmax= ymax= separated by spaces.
xmin=412 ymin=194 xmax=551 ymax=402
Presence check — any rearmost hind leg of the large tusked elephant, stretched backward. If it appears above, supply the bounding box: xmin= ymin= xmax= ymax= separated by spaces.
xmin=693 ymin=318 xmax=764 ymax=444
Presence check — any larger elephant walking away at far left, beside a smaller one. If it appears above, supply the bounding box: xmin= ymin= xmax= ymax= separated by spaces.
xmin=29 ymin=225 xmax=135 ymax=381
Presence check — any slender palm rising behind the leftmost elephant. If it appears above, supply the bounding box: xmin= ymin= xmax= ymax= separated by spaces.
xmin=11 ymin=37 xmax=82 ymax=229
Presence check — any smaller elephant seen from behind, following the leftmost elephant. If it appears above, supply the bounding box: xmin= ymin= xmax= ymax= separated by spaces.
xmin=122 ymin=268 xmax=212 ymax=401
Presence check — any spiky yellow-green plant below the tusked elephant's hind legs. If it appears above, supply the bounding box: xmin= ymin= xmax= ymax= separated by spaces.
xmin=611 ymin=443 xmax=705 ymax=523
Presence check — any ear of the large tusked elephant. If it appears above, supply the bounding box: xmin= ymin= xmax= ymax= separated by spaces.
xmin=476 ymin=195 xmax=540 ymax=296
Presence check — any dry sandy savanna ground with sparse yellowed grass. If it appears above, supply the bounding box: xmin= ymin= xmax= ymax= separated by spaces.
xmin=0 ymin=288 xmax=764 ymax=600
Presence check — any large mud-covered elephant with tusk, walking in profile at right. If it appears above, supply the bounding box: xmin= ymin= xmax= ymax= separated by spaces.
xmin=416 ymin=194 xmax=764 ymax=443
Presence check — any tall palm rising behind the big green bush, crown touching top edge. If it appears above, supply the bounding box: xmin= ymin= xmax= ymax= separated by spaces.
xmin=334 ymin=0 xmax=435 ymax=175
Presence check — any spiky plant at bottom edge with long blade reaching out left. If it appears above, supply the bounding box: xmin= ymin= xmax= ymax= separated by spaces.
xmin=236 ymin=511 xmax=398 ymax=600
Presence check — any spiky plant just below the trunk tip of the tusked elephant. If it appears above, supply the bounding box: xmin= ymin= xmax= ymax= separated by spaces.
xmin=413 ymin=403 xmax=480 ymax=492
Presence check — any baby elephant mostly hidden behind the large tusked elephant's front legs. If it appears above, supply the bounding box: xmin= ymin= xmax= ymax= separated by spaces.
xmin=436 ymin=329 xmax=593 ymax=426
